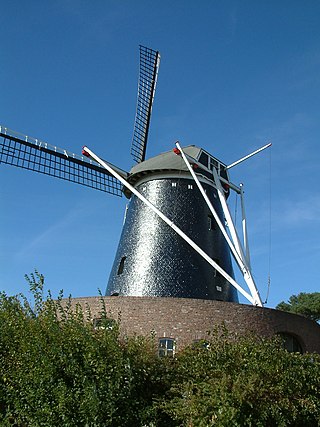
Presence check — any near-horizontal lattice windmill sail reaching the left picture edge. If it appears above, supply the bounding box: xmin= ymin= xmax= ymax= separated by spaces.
xmin=0 ymin=126 xmax=122 ymax=197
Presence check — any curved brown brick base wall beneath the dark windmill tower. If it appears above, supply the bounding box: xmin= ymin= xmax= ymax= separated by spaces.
xmin=65 ymin=296 xmax=320 ymax=354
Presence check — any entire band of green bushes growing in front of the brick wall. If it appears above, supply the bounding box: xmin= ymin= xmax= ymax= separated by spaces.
xmin=0 ymin=272 xmax=320 ymax=427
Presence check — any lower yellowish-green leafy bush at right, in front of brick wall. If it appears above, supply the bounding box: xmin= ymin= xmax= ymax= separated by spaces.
xmin=157 ymin=331 xmax=320 ymax=427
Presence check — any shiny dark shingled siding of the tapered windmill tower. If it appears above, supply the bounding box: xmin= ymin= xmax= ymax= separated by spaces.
xmin=106 ymin=174 xmax=238 ymax=302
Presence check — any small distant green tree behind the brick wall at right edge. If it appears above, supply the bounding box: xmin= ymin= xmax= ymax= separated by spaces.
xmin=276 ymin=292 xmax=320 ymax=322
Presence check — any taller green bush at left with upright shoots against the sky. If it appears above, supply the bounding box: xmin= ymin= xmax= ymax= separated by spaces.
xmin=0 ymin=272 xmax=172 ymax=427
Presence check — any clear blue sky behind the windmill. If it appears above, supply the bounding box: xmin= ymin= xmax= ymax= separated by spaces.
xmin=0 ymin=0 xmax=320 ymax=307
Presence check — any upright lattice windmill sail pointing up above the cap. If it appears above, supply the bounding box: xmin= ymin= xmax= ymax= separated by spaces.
xmin=131 ymin=46 xmax=160 ymax=163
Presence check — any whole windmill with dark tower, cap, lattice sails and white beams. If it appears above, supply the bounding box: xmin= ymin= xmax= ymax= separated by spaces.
xmin=0 ymin=46 xmax=270 ymax=306
